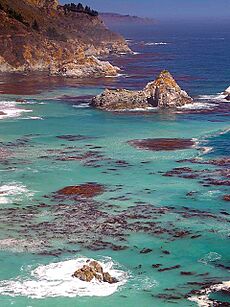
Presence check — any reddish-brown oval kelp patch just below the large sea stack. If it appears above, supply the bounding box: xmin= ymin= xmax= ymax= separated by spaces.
xmin=128 ymin=138 xmax=195 ymax=151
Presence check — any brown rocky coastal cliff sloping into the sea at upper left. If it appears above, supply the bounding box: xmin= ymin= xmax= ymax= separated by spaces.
xmin=0 ymin=0 xmax=130 ymax=77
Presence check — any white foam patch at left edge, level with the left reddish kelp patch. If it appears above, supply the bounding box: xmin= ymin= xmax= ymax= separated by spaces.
xmin=0 ymin=182 xmax=33 ymax=204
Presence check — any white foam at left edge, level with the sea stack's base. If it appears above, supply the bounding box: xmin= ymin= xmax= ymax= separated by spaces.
xmin=0 ymin=101 xmax=32 ymax=120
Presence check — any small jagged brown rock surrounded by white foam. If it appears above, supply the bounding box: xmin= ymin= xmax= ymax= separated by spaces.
xmin=72 ymin=260 xmax=118 ymax=284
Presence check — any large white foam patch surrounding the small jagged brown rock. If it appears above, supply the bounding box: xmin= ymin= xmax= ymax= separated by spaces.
xmin=0 ymin=258 xmax=128 ymax=299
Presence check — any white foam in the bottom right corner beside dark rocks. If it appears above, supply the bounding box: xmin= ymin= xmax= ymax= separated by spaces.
xmin=189 ymin=281 xmax=230 ymax=307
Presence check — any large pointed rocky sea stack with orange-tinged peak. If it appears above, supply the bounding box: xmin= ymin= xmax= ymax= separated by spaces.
xmin=91 ymin=70 xmax=193 ymax=111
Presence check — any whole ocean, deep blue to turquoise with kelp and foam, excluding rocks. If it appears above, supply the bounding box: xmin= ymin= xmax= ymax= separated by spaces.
xmin=0 ymin=22 xmax=230 ymax=307
